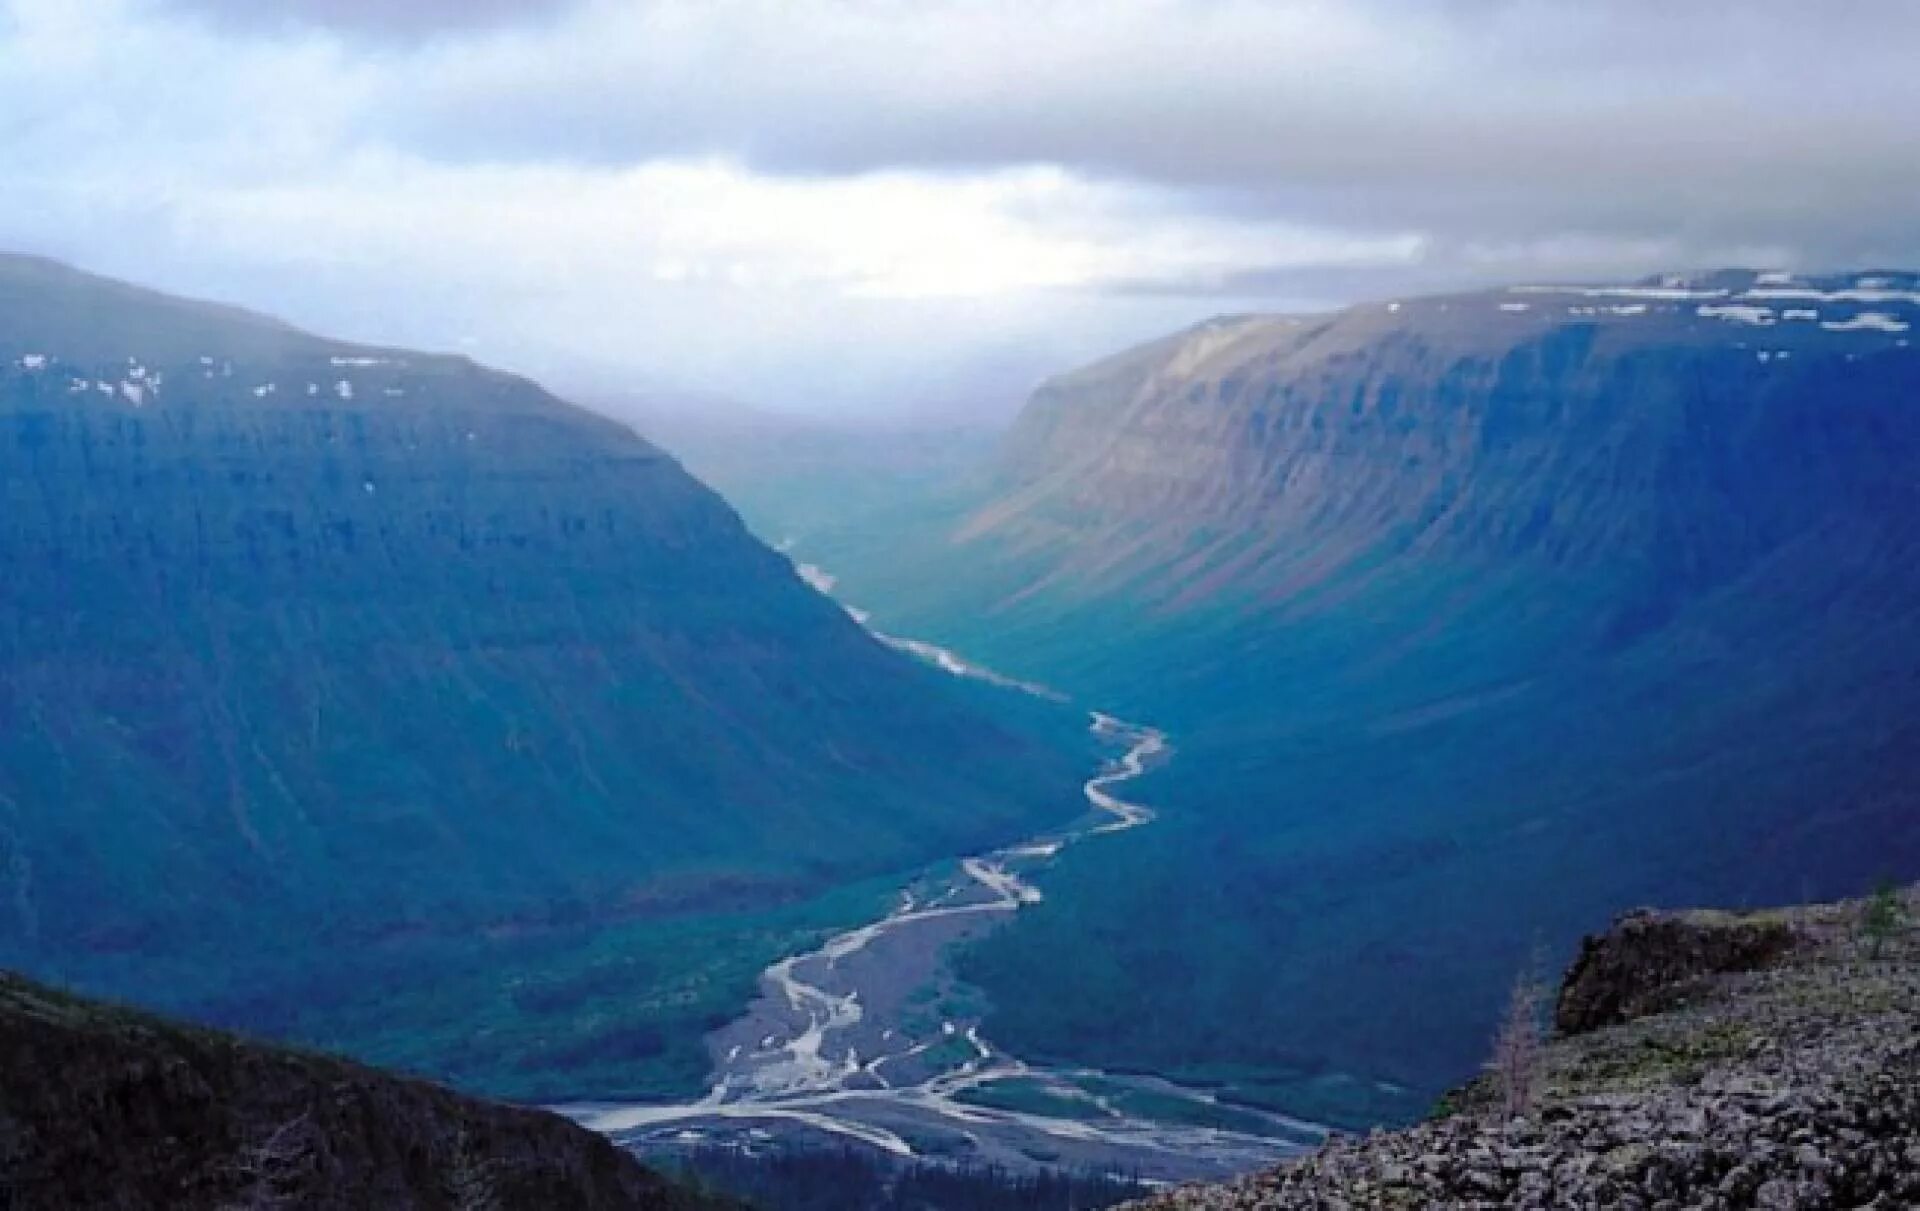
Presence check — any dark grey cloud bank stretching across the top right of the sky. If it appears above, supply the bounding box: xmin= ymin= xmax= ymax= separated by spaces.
xmin=370 ymin=0 xmax=1920 ymax=274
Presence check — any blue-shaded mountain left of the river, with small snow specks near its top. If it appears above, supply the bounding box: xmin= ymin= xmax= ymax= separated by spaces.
xmin=0 ymin=257 xmax=1083 ymax=1092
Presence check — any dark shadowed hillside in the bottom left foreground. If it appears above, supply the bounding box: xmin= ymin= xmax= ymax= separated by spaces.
xmin=0 ymin=973 xmax=732 ymax=1211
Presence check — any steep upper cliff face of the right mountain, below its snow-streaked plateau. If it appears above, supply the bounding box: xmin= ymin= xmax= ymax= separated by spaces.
xmin=962 ymin=273 xmax=1920 ymax=622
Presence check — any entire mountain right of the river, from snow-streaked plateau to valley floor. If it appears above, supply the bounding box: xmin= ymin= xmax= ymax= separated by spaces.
xmin=756 ymin=271 xmax=1920 ymax=1121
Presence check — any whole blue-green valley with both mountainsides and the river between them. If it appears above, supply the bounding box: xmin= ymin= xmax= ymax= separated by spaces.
xmin=0 ymin=259 xmax=1920 ymax=1180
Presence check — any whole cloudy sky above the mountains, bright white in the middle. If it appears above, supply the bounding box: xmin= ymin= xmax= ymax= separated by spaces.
xmin=0 ymin=0 xmax=1920 ymax=416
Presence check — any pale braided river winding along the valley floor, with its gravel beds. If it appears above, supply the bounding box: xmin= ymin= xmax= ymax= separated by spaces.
xmin=557 ymin=564 xmax=1327 ymax=1180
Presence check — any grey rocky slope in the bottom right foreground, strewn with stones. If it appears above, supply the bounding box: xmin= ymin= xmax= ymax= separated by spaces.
xmin=1139 ymin=892 xmax=1920 ymax=1211
